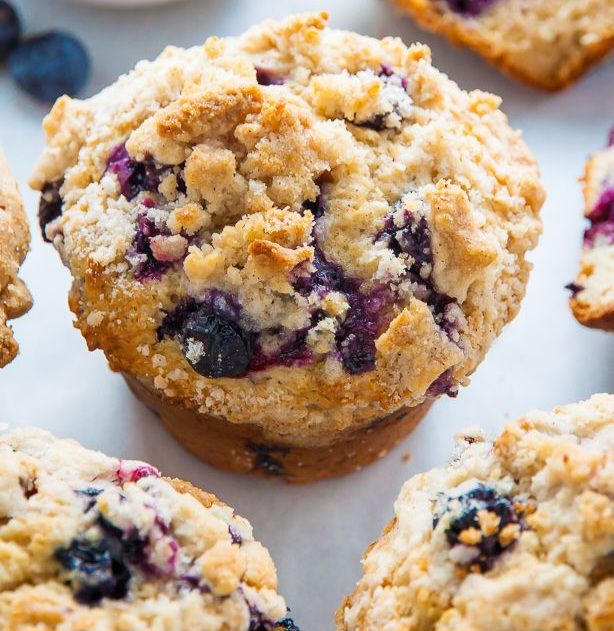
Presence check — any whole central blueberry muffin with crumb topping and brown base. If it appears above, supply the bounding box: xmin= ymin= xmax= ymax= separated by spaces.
xmin=32 ymin=14 xmax=543 ymax=482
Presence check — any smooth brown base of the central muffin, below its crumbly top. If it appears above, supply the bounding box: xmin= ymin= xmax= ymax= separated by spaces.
xmin=123 ymin=373 xmax=433 ymax=484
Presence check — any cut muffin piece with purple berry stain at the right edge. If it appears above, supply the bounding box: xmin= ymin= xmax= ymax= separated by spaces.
xmin=568 ymin=129 xmax=614 ymax=331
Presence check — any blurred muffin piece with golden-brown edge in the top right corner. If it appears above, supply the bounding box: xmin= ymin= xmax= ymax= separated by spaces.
xmin=395 ymin=0 xmax=614 ymax=90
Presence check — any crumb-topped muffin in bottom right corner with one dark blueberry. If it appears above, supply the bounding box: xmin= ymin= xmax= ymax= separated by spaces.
xmin=337 ymin=394 xmax=614 ymax=631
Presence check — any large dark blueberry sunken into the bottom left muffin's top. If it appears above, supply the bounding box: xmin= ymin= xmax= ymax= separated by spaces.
xmin=55 ymin=538 xmax=131 ymax=605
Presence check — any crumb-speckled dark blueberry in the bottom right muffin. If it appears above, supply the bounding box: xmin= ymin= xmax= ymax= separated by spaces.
xmin=433 ymin=484 xmax=524 ymax=572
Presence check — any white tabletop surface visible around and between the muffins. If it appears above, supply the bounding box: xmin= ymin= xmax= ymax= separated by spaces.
xmin=0 ymin=0 xmax=614 ymax=631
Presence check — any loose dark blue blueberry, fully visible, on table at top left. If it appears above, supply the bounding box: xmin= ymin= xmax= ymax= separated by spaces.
xmin=8 ymin=31 xmax=90 ymax=102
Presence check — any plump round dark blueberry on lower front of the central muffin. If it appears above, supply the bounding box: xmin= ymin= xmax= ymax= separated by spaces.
xmin=182 ymin=313 xmax=254 ymax=378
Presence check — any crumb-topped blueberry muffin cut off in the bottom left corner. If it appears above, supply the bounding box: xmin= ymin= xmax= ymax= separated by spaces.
xmin=0 ymin=429 xmax=294 ymax=631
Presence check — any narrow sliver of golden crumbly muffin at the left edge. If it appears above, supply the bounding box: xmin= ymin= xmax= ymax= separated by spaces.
xmin=0 ymin=151 xmax=32 ymax=368
